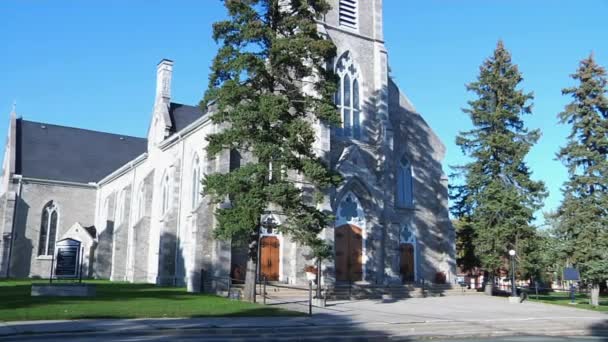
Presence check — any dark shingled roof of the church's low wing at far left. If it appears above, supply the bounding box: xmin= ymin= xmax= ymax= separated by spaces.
xmin=16 ymin=119 xmax=148 ymax=183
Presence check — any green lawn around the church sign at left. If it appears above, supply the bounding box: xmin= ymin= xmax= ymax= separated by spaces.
xmin=0 ymin=280 xmax=299 ymax=321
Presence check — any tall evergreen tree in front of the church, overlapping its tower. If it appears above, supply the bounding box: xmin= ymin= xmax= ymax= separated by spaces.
xmin=202 ymin=0 xmax=340 ymax=300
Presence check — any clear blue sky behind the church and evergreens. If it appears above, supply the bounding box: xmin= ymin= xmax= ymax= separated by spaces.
xmin=0 ymin=0 xmax=608 ymax=219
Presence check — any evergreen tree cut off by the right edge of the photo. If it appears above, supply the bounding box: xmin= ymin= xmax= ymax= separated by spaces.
xmin=557 ymin=55 xmax=608 ymax=305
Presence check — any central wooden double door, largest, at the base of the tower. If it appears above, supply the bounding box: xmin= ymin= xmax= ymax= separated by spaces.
xmin=334 ymin=224 xmax=363 ymax=282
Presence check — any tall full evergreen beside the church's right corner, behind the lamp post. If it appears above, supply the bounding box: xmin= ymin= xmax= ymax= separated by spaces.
xmin=451 ymin=41 xmax=546 ymax=290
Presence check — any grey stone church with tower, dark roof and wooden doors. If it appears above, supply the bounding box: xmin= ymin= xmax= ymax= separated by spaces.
xmin=0 ymin=0 xmax=455 ymax=291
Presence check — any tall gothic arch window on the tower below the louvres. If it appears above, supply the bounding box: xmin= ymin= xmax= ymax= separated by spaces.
xmin=336 ymin=52 xmax=361 ymax=139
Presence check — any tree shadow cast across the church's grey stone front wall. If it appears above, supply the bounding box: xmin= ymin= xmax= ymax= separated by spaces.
xmin=325 ymin=81 xmax=454 ymax=292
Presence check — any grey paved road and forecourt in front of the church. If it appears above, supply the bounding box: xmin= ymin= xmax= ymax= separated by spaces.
xmin=0 ymin=296 xmax=608 ymax=342
